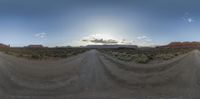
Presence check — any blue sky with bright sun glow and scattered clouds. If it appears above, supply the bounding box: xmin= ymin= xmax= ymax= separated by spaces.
xmin=0 ymin=0 xmax=200 ymax=46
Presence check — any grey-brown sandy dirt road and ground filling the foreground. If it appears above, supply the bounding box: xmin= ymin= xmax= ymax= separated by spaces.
xmin=0 ymin=50 xmax=200 ymax=99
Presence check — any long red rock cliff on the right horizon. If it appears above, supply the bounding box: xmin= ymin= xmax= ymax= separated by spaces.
xmin=166 ymin=42 xmax=200 ymax=48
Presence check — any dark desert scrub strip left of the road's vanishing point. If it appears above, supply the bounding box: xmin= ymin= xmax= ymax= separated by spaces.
xmin=0 ymin=48 xmax=87 ymax=60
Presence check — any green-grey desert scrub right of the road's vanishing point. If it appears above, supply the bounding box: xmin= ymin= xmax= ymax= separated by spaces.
xmin=100 ymin=48 xmax=192 ymax=63
